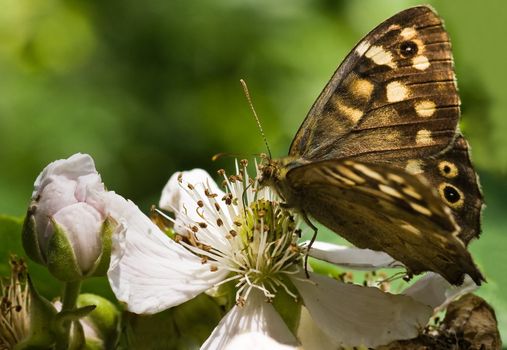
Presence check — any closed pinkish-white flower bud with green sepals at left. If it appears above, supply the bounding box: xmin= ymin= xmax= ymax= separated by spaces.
xmin=23 ymin=153 xmax=113 ymax=281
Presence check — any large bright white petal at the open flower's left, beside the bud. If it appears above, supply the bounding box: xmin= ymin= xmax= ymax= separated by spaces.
xmin=103 ymin=192 xmax=227 ymax=314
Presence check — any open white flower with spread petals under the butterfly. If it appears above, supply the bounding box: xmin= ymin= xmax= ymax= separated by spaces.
xmin=105 ymin=165 xmax=456 ymax=349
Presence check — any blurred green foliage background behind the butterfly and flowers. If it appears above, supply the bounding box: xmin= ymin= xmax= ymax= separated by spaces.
xmin=0 ymin=0 xmax=507 ymax=344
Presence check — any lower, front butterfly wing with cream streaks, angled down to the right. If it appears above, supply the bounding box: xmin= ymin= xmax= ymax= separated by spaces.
xmin=287 ymin=160 xmax=484 ymax=284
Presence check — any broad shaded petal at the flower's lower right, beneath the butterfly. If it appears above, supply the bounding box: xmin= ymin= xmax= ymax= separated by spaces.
xmin=292 ymin=273 xmax=433 ymax=347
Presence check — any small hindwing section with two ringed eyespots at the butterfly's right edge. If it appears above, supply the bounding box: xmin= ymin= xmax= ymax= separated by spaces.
xmin=421 ymin=135 xmax=484 ymax=244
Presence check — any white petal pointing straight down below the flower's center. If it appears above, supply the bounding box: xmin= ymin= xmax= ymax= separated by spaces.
xmin=201 ymin=292 xmax=297 ymax=350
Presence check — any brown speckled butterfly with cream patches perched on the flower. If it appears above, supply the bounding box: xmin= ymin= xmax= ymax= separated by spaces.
xmin=259 ymin=6 xmax=485 ymax=285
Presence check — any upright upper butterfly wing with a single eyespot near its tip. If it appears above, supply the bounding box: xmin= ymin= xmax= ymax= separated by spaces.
xmin=289 ymin=6 xmax=459 ymax=163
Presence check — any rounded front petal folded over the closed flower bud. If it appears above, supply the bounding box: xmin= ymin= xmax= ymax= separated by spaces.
xmin=53 ymin=203 xmax=104 ymax=274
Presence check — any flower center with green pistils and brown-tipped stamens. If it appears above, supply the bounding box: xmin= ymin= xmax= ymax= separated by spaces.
xmin=169 ymin=161 xmax=304 ymax=304
